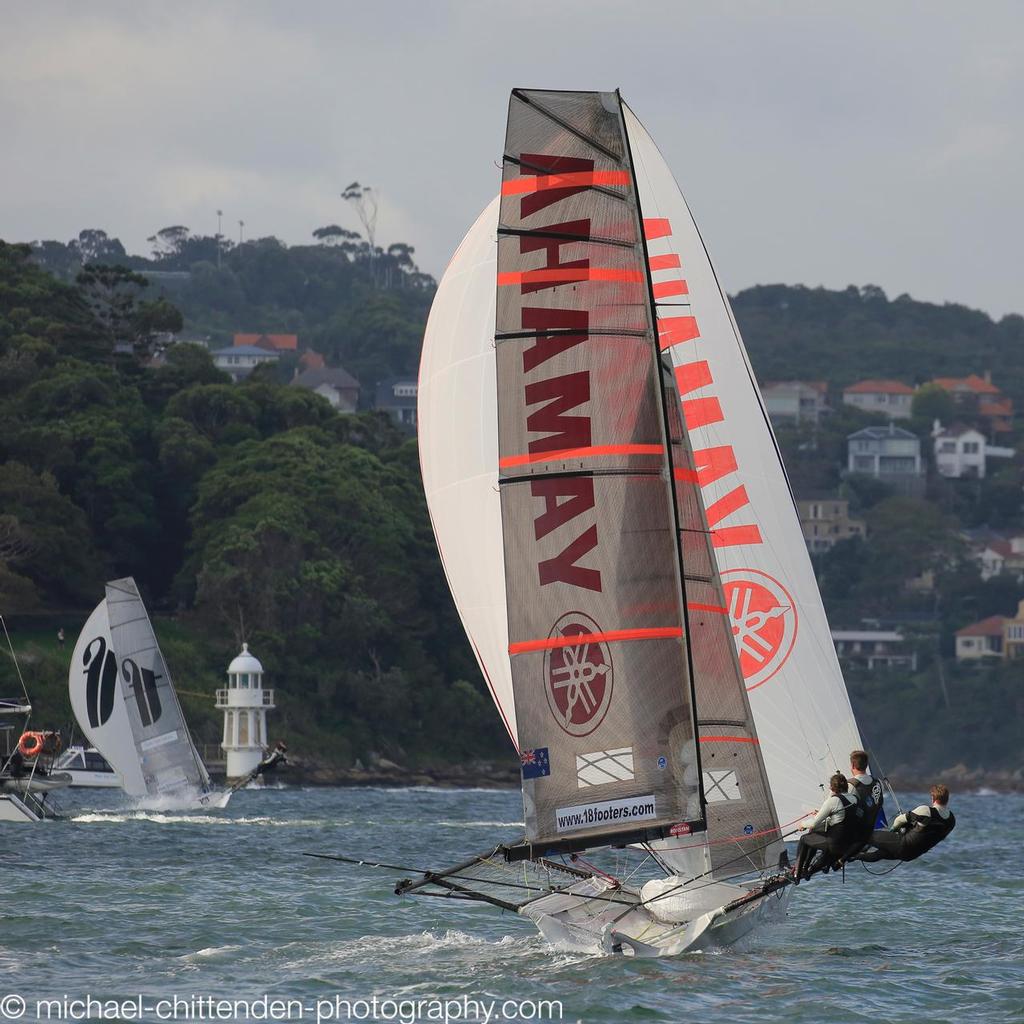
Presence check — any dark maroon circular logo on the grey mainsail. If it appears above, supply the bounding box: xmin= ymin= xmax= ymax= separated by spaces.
xmin=544 ymin=611 xmax=612 ymax=736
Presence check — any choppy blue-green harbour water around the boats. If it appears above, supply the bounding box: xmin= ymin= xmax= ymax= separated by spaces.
xmin=0 ymin=788 xmax=1024 ymax=1024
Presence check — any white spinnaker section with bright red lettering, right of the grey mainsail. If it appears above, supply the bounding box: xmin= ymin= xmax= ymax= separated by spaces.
xmin=624 ymin=108 xmax=861 ymax=824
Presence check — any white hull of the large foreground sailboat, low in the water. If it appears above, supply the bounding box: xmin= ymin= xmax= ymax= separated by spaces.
xmin=519 ymin=878 xmax=792 ymax=956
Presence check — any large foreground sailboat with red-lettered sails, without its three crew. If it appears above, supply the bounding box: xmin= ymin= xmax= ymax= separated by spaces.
xmin=368 ymin=89 xmax=861 ymax=955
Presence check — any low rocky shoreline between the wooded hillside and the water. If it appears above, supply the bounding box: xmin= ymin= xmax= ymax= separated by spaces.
xmin=266 ymin=761 xmax=1024 ymax=795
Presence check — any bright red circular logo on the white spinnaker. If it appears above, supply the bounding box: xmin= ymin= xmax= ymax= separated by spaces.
xmin=722 ymin=569 xmax=797 ymax=690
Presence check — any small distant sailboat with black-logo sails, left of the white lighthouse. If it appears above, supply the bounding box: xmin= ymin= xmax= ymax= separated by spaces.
xmin=68 ymin=577 xmax=229 ymax=808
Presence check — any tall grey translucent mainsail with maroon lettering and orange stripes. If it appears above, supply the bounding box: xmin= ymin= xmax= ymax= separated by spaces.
xmin=495 ymin=89 xmax=705 ymax=856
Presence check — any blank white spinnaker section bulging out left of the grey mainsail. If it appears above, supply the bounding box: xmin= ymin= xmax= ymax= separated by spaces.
xmin=417 ymin=199 xmax=516 ymax=742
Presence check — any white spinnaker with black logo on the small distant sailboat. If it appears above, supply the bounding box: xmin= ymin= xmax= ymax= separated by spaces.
xmin=68 ymin=600 xmax=148 ymax=797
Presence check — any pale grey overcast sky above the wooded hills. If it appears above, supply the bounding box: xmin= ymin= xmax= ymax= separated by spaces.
xmin=0 ymin=0 xmax=1024 ymax=316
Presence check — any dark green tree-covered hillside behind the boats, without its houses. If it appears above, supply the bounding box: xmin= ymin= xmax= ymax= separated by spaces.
xmin=0 ymin=225 xmax=1024 ymax=770
